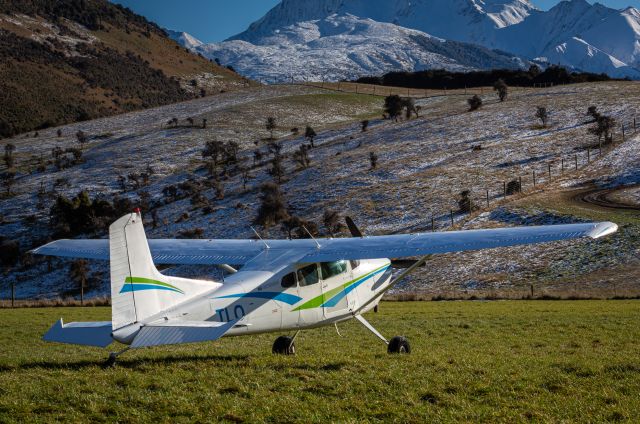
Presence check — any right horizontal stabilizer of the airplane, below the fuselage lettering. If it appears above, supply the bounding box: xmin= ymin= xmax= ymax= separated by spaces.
xmin=131 ymin=321 xmax=237 ymax=347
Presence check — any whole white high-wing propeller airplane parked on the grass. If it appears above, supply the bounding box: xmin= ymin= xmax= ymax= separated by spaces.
xmin=34 ymin=211 xmax=618 ymax=363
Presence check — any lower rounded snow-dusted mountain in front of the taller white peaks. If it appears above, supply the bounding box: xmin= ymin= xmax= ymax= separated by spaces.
xmin=196 ymin=15 xmax=526 ymax=82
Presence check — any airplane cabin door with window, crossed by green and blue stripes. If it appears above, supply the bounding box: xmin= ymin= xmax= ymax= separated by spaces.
xmin=320 ymin=261 xmax=353 ymax=318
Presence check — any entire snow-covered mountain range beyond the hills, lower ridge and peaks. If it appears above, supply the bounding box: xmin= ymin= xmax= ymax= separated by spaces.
xmin=175 ymin=0 xmax=640 ymax=81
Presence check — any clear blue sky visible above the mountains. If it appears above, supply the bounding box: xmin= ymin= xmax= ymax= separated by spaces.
xmin=113 ymin=0 xmax=640 ymax=42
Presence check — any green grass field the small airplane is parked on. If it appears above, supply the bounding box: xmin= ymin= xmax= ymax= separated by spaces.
xmin=0 ymin=301 xmax=640 ymax=422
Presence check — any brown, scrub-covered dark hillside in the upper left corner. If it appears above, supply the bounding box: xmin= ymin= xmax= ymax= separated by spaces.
xmin=0 ymin=0 xmax=247 ymax=137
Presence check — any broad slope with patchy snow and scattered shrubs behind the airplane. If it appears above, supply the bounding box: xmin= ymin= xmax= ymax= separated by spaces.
xmin=0 ymin=82 xmax=640 ymax=298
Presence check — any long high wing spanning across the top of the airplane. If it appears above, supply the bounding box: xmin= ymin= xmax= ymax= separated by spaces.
xmin=32 ymin=222 xmax=618 ymax=265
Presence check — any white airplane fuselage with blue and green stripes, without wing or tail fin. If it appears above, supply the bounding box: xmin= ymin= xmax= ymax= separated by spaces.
xmin=114 ymin=259 xmax=391 ymax=342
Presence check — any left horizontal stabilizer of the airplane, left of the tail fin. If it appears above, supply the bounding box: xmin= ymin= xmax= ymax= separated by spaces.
xmin=42 ymin=318 xmax=113 ymax=347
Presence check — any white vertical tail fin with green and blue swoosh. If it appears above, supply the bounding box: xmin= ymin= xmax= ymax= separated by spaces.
xmin=109 ymin=213 xmax=219 ymax=330
